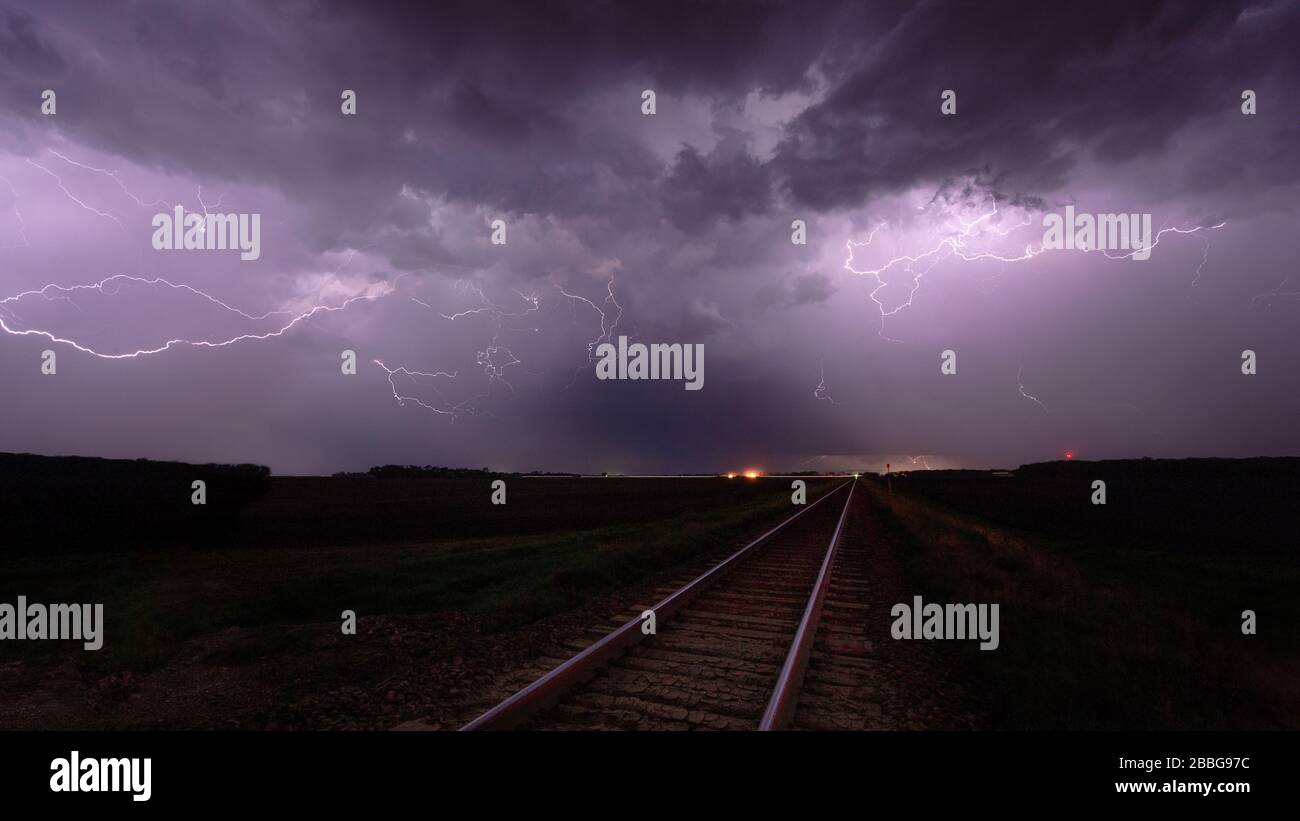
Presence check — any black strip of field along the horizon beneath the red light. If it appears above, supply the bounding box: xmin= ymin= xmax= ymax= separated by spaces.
xmin=893 ymin=457 xmax=1300 ymax=553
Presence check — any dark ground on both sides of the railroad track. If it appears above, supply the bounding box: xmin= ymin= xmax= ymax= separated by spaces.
xmin=0 ymin=460 xmax=1300 ymax=729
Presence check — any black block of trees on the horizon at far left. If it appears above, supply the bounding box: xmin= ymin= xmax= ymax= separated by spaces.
xmin=0 ymin=453 xmax=270 ymax=553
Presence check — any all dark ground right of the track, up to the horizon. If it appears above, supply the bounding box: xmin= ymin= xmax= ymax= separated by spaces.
xmin=874 ymin=460 xmax=1300 ymax=729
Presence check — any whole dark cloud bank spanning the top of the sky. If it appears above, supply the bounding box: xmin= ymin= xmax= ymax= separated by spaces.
xmin=4 ymin=0 xmax=1300 ymax=230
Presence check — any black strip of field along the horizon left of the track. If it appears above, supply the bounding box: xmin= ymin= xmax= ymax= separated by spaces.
xmin=0 ymin=453 xmax=811 ymax=555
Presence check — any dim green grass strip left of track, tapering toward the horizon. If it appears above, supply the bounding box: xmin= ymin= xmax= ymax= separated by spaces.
xmin=0 ymin=486 xmax=829 ymax=670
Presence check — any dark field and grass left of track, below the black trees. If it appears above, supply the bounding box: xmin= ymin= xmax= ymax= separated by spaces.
xmin=0 ymin=468 xmax=831 ymax=729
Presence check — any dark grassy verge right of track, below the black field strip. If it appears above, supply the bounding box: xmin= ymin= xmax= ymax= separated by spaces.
xmin=876 ymin=480 xmax=1300 ymax=729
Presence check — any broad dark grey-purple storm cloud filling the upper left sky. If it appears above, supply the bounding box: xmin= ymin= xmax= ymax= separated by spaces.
xmin=5 ymin=1 xmax=829 ymax=229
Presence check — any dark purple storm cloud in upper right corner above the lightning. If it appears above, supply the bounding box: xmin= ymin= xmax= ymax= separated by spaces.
xmin=776 ymin=0 xmax=1300 ymax=209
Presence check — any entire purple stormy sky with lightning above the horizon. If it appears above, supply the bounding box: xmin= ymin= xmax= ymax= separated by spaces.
xmin=0 ymin=0 xmax=1300 ymax=473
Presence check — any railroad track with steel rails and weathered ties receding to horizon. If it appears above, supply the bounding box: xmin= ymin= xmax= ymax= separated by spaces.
xmin=462 ymin=481 xmax=857 ymax=730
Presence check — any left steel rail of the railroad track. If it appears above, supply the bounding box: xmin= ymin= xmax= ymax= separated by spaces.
xmin=460 ymin=479 xmax=853 ymax=731
